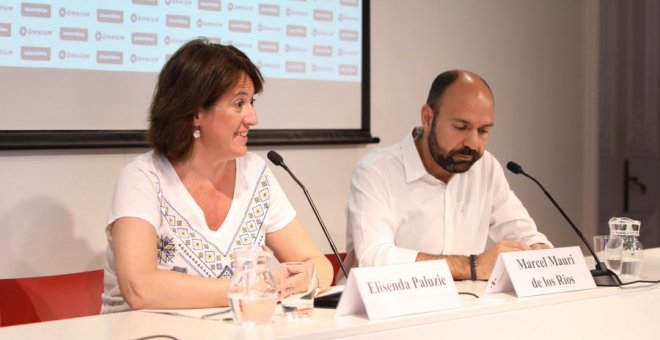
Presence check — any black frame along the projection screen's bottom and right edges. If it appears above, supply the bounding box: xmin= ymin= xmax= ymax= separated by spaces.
xmin=0 ymin=0 xmax=380 ymax=150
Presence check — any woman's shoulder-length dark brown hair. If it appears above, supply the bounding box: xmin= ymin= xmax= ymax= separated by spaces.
xmin=147 ymin=38 xmax=263 ymax=163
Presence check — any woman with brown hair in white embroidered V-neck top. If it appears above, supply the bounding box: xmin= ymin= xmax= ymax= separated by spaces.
xmin=101 ymin=39 xmax=333 ymax=313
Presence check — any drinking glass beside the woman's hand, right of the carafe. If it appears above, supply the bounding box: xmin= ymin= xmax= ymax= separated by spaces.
xmin=280 ymin=262 xmax=319 ymax=318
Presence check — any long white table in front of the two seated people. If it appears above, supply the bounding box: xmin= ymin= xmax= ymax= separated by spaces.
xmin=5 ymin=248 xmax=660 ymax=340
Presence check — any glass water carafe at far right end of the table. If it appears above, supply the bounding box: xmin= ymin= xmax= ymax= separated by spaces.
xmin=609 ymin=217 xmax=644 ymax=281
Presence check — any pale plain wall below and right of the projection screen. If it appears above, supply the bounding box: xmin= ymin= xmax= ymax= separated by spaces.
xmin=0 ymin=0 xmax=597 ymax=278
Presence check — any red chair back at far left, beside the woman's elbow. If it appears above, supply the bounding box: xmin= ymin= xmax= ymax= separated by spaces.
xmin=0 ymin=270 xmax=103 ymax=326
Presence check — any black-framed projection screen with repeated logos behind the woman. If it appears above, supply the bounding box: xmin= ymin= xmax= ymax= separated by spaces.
xmin=0 ymin=0 xmax=378 ymax=149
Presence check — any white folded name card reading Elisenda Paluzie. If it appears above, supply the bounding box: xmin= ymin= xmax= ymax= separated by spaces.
xmin=335 ymin=260 xmax=460 ymax=320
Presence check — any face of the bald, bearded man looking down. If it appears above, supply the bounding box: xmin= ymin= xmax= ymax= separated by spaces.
xmin=428 ymin=78 xmax=494 ymax=173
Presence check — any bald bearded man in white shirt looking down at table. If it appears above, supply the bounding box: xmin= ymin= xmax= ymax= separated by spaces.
xmin=346 ymin=70 xmax=551 ymax=280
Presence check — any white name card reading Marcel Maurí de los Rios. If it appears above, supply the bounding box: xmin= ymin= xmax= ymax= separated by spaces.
xmin=484 ymin=247 xmax=596 ymax=297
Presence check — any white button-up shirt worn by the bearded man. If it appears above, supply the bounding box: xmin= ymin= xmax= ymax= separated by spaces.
xmin=346 ymin=133 xmax=550 ymax=274
